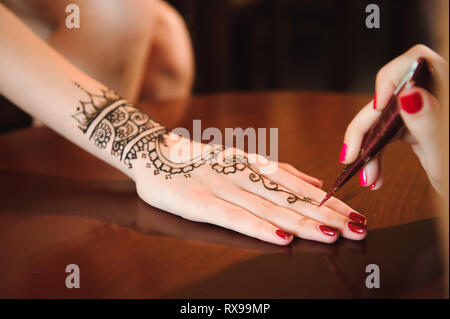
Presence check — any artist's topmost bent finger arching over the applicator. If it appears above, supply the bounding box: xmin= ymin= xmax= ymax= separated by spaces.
xmin=375 ymin=44 xmax=448 ymax=110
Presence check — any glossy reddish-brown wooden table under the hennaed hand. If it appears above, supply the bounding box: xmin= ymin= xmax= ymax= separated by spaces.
xmin=0 ymin=92 xmax=443 ymax=298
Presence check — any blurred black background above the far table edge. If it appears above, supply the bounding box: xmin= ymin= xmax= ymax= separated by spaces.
xmin=0 ymin=0 xmax=437 ymax=132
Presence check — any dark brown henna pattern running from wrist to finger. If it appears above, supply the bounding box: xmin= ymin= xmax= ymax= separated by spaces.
xmin=72 ymin=82 xmax=319 ymax=206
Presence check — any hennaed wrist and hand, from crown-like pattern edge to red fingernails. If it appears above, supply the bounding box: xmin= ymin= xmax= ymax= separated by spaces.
xmin=73 ymin=83 xmax=366 ymax=245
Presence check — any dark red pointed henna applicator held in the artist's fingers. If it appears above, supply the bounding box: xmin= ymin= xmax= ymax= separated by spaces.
xmin=319 ymin=58 xmax=432 ymax=207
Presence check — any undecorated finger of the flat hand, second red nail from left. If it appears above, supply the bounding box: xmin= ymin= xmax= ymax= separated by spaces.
xmin=217 ymin=188 xmax=339 ymax=243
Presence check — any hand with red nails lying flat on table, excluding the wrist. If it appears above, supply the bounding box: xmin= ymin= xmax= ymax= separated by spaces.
xmin=133 ymin=134 xmax=366 ymax=245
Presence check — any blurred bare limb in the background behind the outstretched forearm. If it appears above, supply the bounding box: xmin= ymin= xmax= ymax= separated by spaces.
xmin=0 ymin=0 xmax=194 ymax=102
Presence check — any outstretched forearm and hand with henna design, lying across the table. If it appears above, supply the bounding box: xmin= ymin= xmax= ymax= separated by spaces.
xmin=0 ymin=4 xmax=366 ymax=245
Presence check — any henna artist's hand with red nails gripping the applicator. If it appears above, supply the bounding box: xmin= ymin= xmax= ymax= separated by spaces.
xmin=340 ymin=45 xmax=448 ymax=191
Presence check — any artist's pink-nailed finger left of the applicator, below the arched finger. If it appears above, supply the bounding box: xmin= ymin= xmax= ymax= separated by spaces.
xmin=339 ymin=101 xmax=381 ymax=164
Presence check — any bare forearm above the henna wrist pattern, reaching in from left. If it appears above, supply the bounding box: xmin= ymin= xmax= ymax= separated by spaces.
xmin=0 ymin=4 xmax=144 ymax=177
